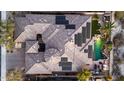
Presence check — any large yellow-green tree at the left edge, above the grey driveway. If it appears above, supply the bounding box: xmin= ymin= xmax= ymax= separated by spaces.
xmin=0 ymin=18 xmax=15 ymax=50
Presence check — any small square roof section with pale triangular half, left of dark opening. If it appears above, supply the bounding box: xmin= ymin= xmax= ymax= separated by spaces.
xmin=25 ymin=40 xmax=39 ymax=53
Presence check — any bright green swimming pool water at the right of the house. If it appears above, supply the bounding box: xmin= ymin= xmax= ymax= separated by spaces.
xmin=94 ymin=38 xmax=104 ymax=61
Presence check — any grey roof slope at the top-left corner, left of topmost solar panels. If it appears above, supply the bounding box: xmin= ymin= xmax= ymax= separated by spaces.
xmin=14 ymin=14 xmax=55 ymax=39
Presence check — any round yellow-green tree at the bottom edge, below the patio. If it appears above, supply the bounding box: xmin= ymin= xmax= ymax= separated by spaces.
xmin=77 ymin=69 xmax=91 ymax=81
